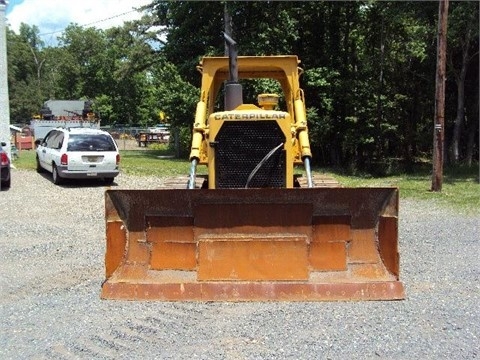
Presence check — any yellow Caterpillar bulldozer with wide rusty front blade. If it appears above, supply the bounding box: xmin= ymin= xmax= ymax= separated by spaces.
xmin=101 ymin=35 xmax=404 ymax=301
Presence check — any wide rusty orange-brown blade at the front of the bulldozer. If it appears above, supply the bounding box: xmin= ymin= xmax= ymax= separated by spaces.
xmin=101 ymin=188 xmax=404 ymax=301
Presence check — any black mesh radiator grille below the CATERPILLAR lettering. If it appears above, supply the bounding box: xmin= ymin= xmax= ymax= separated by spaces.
xmin=213 ymin=121 xmax=286 ymax=189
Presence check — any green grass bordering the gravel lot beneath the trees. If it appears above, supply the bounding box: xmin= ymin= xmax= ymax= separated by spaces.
xmin=13 ymin=147 xmax=480 ymax=214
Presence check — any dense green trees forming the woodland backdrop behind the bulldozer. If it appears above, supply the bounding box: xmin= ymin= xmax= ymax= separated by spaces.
xmin=7 ymin=0 xmax=479 ymax=171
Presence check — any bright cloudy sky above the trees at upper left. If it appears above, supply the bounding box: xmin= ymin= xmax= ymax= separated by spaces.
xmin=6 ymin=0 xmax=151 ymax=46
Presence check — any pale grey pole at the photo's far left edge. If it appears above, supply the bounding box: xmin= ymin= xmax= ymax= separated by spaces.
xmin=0 ymin=0 xmax=12 ymax=159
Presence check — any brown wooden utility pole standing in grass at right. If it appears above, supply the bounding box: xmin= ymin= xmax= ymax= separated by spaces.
xmin=431 ymin=0 xmax=448 ymax=192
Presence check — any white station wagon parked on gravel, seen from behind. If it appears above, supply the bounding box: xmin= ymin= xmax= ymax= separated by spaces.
xmin=36 ymin=128 xmax=120 ymax=185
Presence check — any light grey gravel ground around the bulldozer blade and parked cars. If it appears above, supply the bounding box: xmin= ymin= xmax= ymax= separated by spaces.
xmin=0 ymin=170 xmax=480 ymax=359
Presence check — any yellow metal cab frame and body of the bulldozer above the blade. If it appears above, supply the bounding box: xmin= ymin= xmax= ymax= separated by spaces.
xmin=190 ymin=55 xmax=311 ymax=188
